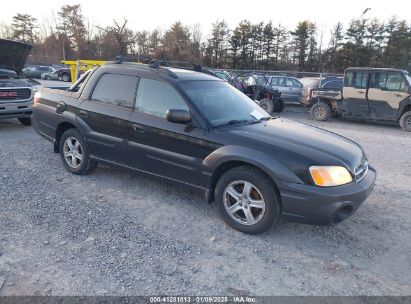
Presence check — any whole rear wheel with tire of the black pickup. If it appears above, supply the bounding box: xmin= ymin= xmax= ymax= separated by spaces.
xmin=59 ymin=129 xmax=97 ymax=175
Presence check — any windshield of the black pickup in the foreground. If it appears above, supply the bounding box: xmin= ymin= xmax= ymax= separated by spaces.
xmin=181 ymin=81 xmax=271 ymax=127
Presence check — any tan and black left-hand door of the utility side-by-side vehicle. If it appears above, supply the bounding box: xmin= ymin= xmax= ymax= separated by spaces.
xmin=343 ymin=71 xmax=370 ymax=118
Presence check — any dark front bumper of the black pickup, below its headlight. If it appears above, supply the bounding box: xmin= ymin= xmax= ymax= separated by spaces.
xmin=278 ymin=167 xmax=377 ymax=225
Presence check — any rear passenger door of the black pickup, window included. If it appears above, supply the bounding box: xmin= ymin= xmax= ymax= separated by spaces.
xmin=78 ymin=73 xmax=138 ymax=164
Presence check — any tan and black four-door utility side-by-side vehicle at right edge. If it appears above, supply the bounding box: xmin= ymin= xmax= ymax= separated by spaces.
xmin=310 ymin=68 xmax=411 ymax=132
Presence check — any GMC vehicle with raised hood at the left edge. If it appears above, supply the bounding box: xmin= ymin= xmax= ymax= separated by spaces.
xmin=0 ymin=39 xmax=40 ymax=125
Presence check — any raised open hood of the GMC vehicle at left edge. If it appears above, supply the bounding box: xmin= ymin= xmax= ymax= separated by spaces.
xmin=0 ymin=39 xmax=32 ymax=73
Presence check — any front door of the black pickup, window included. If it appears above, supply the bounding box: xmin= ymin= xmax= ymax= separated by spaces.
xmin=128 ymin=78 xmax=205 ymax=185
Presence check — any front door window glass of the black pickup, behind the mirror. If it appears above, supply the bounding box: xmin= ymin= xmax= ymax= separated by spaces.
xmin=136 ymin=78 xmax=189 ymax=118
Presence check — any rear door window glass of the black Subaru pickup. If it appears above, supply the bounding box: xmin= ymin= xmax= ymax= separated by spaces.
xmin=91 ymin=74 xmax=138 ymax=108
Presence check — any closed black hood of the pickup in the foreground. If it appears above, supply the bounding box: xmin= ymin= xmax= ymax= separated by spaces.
xmin=226 ymin=118 xmax=365 ymax=170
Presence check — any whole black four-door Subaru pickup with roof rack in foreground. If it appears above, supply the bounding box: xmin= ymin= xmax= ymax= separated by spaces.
xmin=33 ymin=63 xmax=376 ymax=233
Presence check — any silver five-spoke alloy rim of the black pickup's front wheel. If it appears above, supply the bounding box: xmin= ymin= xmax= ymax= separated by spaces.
xmin=224 ymin=181 xmax=265 ymax=225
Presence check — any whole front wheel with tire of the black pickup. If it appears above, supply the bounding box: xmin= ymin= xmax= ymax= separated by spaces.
xmin=215 ymin=166 xmax=281 ymax=234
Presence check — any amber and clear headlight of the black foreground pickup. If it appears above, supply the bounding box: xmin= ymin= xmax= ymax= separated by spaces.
xmin=310 ymin=166 xmax=352 ymax=187
